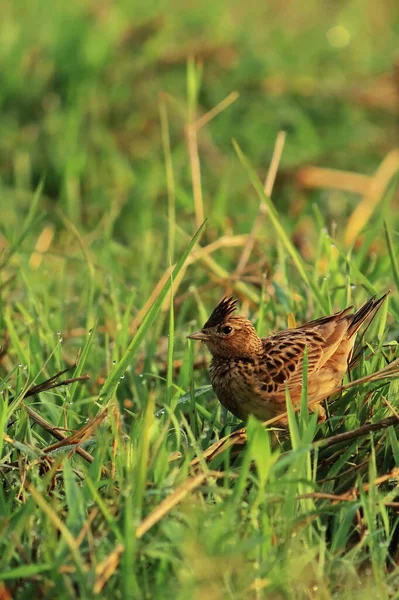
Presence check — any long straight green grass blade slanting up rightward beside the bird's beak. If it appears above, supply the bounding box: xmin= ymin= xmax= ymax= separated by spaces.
xmin=99 ymin=221 xmax=205 ymax=401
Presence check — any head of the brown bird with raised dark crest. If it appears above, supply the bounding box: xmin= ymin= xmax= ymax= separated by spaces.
xmin=187 ymin=298 xmax=262 ymax=356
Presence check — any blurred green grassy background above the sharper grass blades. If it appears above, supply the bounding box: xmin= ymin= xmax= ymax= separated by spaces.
xmin=0 ymin=0 xmax=399 ymax=241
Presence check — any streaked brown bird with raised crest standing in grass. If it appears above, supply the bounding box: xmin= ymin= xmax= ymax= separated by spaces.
xmin=187 ymin=294 xmax=387 ymax=425
